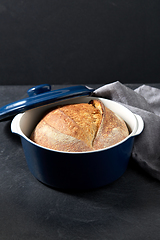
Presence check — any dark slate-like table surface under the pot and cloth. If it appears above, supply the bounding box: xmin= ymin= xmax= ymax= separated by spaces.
xmin=0 ymin=84 xmax=160 ymax=240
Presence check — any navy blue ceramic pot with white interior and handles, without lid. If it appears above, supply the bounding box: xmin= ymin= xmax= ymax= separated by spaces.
xmin=11 ymin=97 xmax=144 ymax=190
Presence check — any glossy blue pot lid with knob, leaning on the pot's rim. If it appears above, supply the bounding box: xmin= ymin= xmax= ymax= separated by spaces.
xmin=0 ymin=84 xmax=94 ymax=121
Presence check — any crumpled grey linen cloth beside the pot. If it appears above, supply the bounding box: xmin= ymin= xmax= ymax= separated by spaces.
xmin=94 ymin=81 xmax=160 ymax=180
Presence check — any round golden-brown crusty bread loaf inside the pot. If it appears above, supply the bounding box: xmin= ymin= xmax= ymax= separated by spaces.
xmin=30 ymin=100 xmax=129 ymax=152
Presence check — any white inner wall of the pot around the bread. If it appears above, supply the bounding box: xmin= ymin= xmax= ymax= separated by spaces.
xmin=19 ymin=97 xmax=137 ymax=151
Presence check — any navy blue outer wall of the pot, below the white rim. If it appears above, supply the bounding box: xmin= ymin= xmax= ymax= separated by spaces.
xmin=21 ymin=137 xmax=134 ymax=190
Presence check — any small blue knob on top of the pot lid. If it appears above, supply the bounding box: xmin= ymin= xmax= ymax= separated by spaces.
xmin=27 ymin=84 xmax=51 ymax=97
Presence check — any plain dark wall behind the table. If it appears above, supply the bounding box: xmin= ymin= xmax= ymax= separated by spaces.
xmin=0 ymin=0 xmax=160 ymax=84
